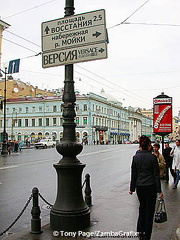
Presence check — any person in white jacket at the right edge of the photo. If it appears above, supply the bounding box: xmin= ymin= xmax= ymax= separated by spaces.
xmin=170 ymin=139 xmax=180 ymax=189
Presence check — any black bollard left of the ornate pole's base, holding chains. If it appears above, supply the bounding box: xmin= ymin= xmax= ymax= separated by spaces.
xmin=30 ymin=187 xmax=42 ymax=234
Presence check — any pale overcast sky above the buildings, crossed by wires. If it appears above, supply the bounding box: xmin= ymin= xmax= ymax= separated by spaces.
xmin=0 ymin=0 xmax=180 ymax=115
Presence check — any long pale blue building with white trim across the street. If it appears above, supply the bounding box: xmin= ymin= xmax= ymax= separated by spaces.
xmin=0 ymin=93 xmax=152 ymax=144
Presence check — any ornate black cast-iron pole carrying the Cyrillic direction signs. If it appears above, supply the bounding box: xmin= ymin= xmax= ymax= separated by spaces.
xmin=50 ymin=0 xmax=90 ymax=231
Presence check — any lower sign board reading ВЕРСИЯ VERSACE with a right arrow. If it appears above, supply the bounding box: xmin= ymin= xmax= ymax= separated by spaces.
xmin=42 ymin=43 xmax=107 ymax=68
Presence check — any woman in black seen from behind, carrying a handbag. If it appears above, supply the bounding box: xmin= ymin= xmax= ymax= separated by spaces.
xmin=129 ymin=136 xmax=163 ymax=240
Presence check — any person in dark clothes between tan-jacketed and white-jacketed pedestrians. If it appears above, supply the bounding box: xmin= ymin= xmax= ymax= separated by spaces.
xmin=163 ymin=143 xmax=175 ymax=183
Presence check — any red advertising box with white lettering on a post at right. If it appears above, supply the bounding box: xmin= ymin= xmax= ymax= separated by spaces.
xmin=153 ymin=93 xmax=172 ymax=136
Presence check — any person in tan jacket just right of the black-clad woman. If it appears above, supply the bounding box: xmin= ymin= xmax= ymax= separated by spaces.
xmin=153 ymin=143 xmax=166 ymax=179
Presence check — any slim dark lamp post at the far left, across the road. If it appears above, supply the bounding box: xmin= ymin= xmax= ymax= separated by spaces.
xmin=0 ymin=68 xmax=8 ymax=155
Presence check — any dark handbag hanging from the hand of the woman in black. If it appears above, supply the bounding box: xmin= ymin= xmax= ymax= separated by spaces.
xmin=154 ymin=199 xmax=167 ymax=223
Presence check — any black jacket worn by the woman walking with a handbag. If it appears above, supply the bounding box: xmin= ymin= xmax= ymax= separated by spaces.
xmin=130 ymin=150 xmax=161 ymax=193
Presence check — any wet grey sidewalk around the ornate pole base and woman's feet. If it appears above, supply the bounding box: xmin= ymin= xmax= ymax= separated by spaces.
xmin=1 ymin=182 xmax=180 ymax=240
